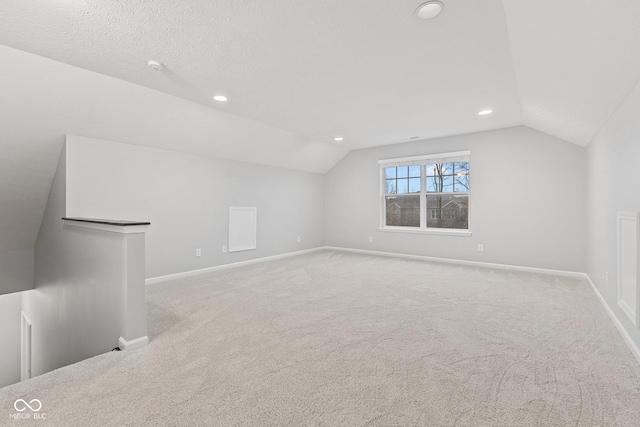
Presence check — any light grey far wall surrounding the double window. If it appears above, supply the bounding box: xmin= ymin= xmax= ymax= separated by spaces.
xmin=325 ymin=126 xmax=586 ymax=272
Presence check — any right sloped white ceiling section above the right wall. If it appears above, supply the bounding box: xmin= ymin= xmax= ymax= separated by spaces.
xmin=504 ymin=0 xmax=640 ymax=146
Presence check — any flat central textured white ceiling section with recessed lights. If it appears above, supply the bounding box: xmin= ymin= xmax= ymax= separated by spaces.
xmin=0 ymin=0 xmax=522 ymax=149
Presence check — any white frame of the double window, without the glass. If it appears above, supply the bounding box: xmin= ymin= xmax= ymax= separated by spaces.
xmin=378 ymin=151 xmax=472 ymax=237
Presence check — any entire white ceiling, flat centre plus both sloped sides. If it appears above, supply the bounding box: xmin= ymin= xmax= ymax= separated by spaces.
xmin=0 ymin=0 xmax=640 ymax=254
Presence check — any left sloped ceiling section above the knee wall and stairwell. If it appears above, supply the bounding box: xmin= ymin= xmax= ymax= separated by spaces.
xmin=0 ymin=45 xmax=347 ymax=252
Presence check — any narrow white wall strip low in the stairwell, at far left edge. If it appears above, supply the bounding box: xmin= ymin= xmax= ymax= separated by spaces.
xmin=0 ymin=292 xmax=22 ymax=387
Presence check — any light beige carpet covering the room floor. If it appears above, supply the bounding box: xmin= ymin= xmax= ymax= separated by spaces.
xmin=0 ymin=251 xmax=640 ymax=427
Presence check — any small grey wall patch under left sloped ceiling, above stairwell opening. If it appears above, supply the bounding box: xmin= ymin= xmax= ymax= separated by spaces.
xmin=0 ymin=248 xmax=33 ymax=294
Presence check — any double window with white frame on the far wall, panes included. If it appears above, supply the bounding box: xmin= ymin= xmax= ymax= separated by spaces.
xmin=378 ymin=151 xmax=471 ymax=235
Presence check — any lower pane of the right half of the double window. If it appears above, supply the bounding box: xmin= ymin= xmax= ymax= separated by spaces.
xmin=427 ymin=194 xmax=469 ymax=230
